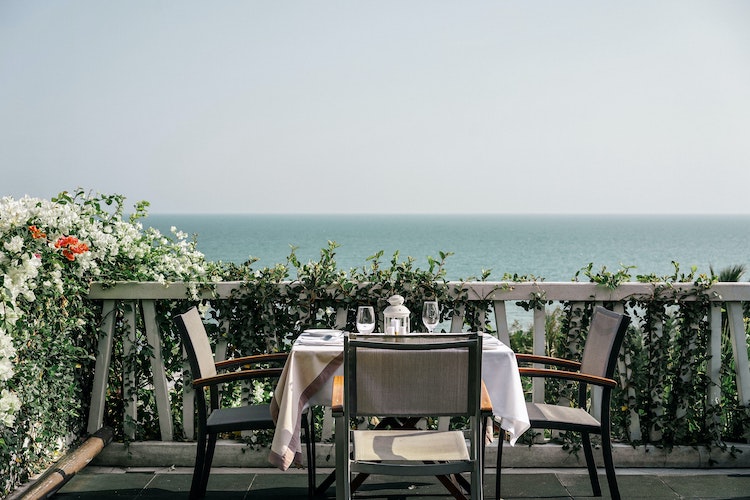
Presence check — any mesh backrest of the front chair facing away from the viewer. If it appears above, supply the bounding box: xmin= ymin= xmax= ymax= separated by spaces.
xmin=344 ymin=334 xmax=482 ymax=417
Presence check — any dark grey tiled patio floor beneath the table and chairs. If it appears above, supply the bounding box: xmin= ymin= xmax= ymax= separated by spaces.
xmin=19 ymin=466 xmax=750 ymax=500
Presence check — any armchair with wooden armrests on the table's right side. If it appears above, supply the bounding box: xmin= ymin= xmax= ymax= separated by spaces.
xmin=496 ymin=307 xmax=630 ymax=499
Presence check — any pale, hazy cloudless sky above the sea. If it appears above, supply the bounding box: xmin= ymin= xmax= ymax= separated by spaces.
xmin=0 ymin=0 xmax=750 ymax=214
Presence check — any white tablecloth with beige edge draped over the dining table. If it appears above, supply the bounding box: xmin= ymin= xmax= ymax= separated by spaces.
xmin=269 ymin=334 xmax=529 ymax=470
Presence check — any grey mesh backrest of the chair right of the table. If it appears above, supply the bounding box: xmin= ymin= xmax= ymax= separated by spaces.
xmin=581 ymin=306 xmax=630 ymax=378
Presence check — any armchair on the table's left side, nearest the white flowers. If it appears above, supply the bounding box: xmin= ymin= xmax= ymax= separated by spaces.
xmin=174 ymin=307 xmax=315 ymax=499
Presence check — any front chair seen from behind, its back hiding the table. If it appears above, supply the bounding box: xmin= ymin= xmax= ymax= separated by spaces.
xmin=332 ymin=334 xmax=492 ymax=499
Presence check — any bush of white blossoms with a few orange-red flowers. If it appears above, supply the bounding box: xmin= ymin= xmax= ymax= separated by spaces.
xmin=0 ymin=190 xmax=217 ymax=496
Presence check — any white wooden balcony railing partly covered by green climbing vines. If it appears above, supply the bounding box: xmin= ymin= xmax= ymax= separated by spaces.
xmin=88 ymin=282 xmax=750 ymax=441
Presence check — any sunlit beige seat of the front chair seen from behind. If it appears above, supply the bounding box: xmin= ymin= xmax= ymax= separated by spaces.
xmin=352 ymin=430 xmax=469 ymax=461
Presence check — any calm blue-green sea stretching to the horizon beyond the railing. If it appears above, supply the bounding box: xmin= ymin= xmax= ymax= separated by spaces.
xmin=143 ymin=214 xmax=750 ymax=281
